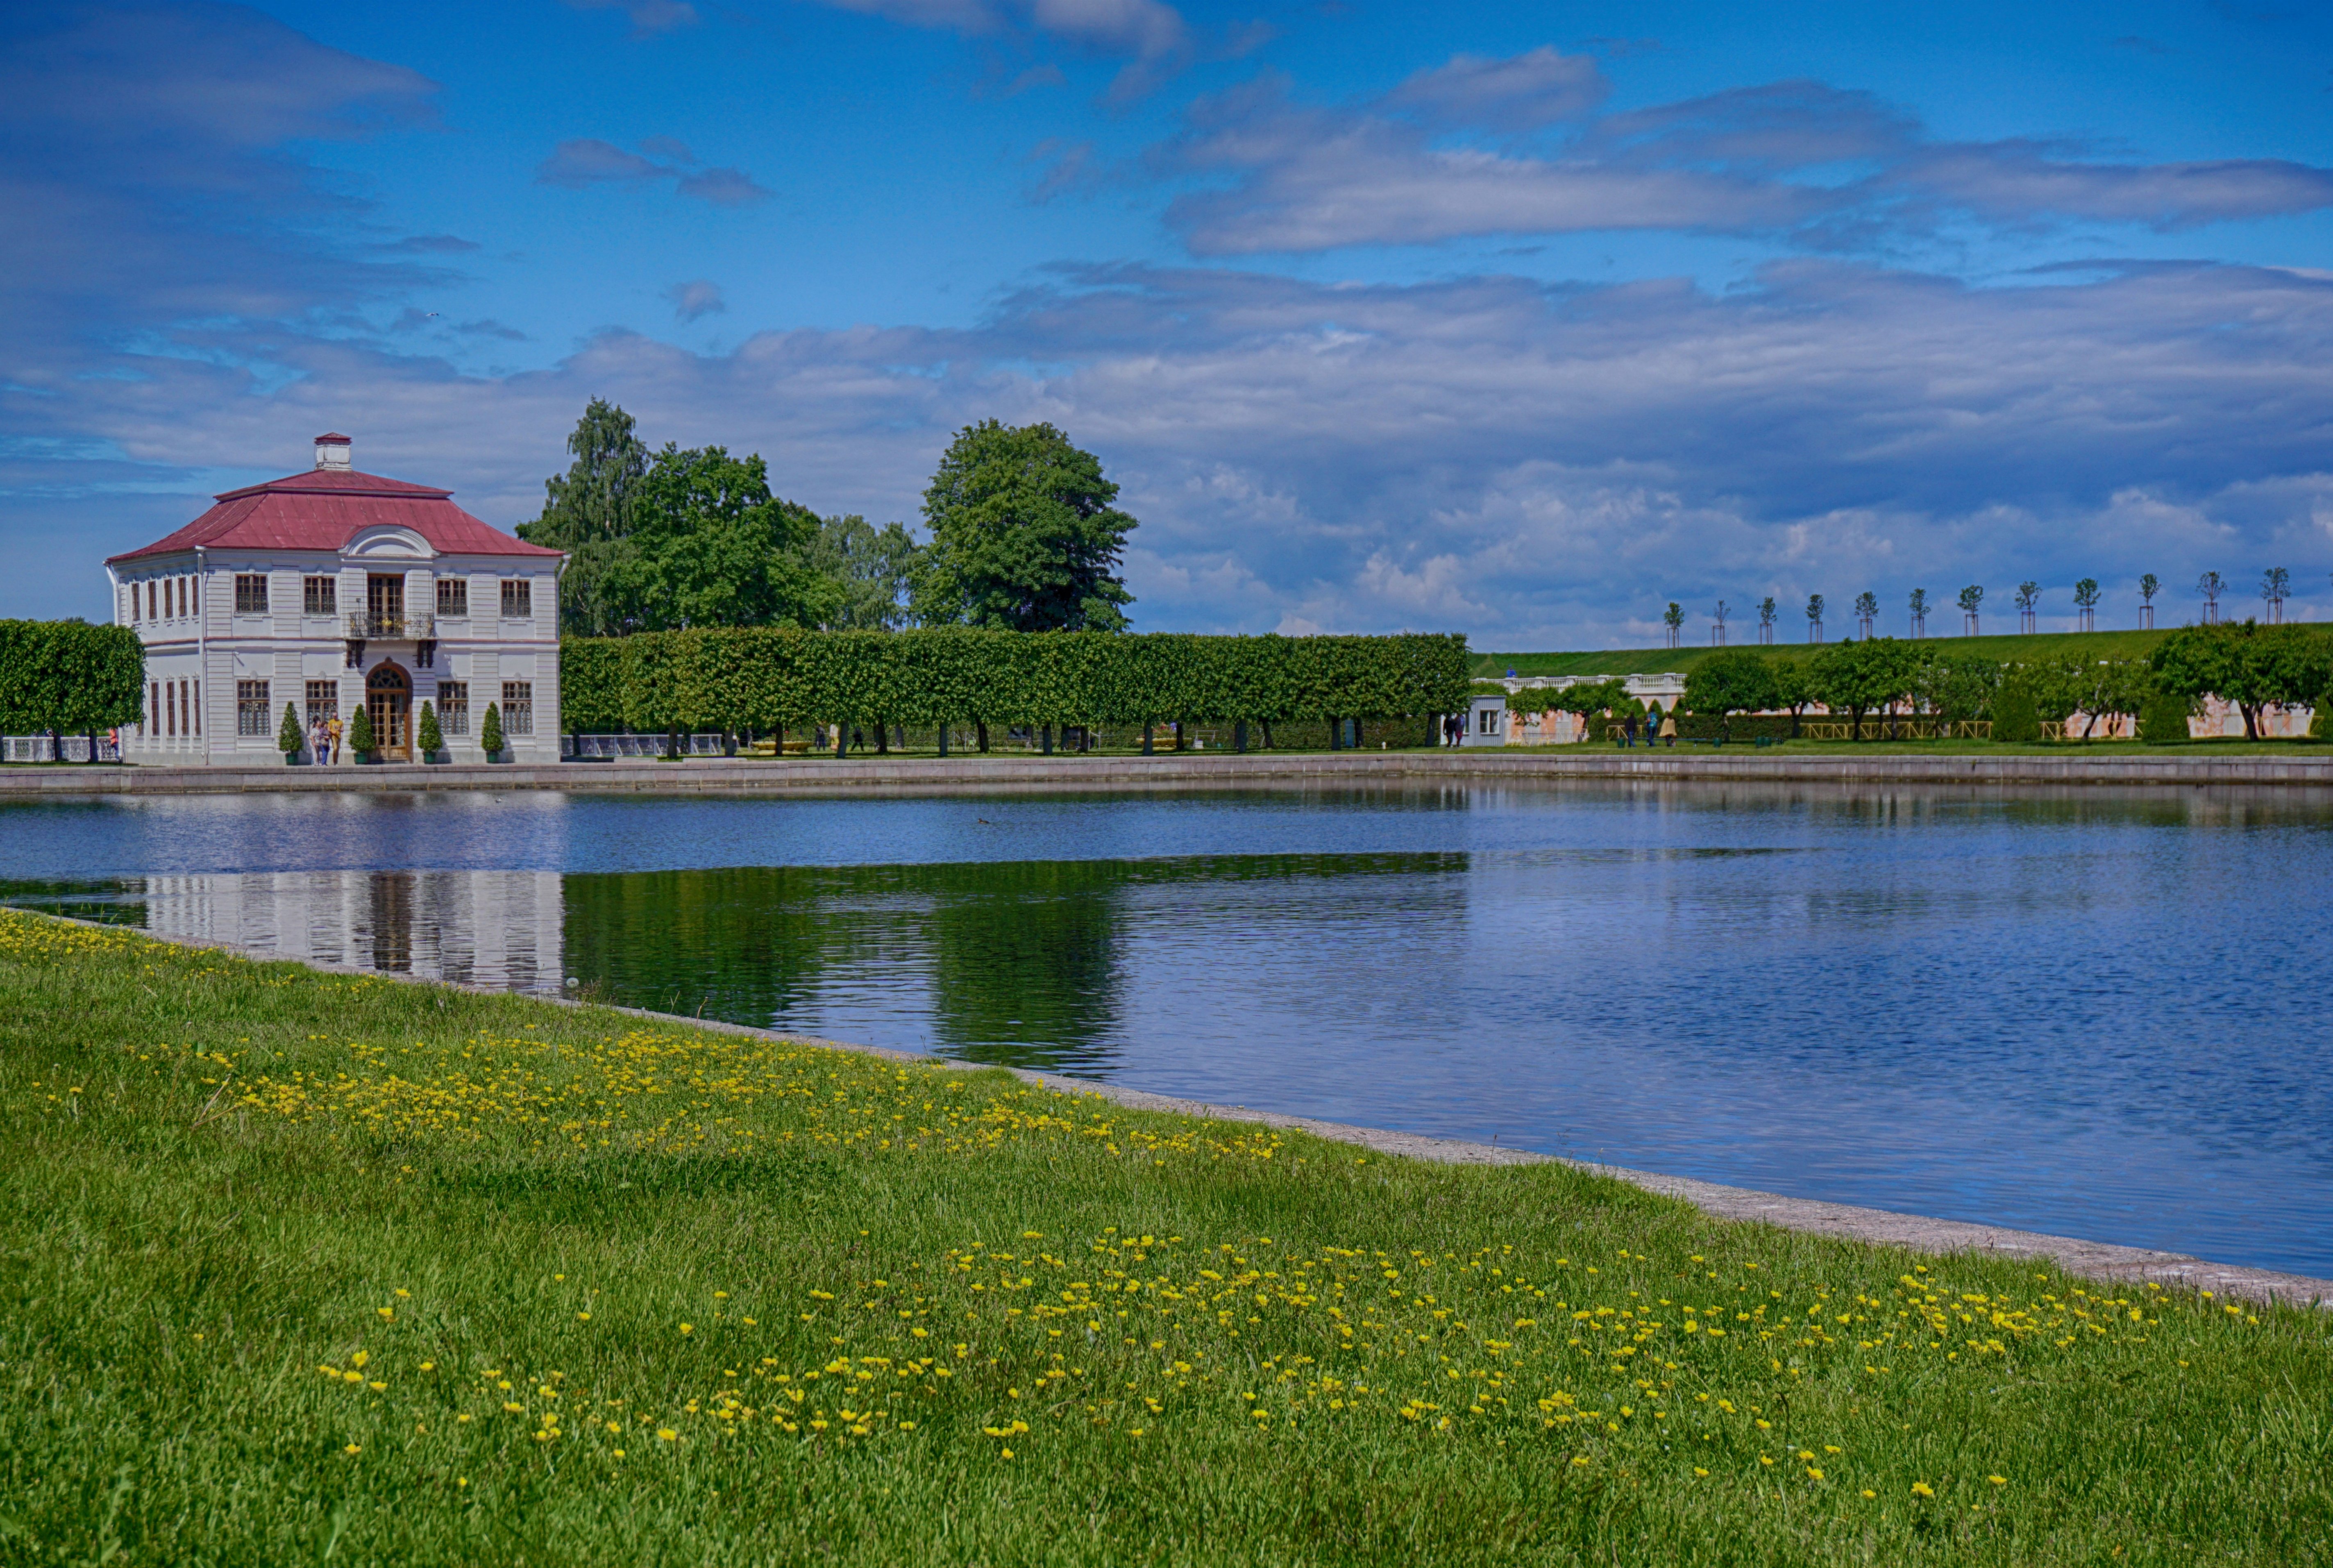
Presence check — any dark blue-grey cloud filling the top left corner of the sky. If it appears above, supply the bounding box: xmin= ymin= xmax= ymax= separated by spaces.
xmin=0 ymin=5 xmax=445 ymax=387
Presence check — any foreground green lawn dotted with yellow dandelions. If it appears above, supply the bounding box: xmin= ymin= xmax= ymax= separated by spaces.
xmin=0 ymin=912 xmax=2333 ymax=1566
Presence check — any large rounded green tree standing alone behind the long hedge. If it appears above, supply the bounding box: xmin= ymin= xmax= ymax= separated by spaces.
xmin=915 ymin=420 xmax=1136 ymax=632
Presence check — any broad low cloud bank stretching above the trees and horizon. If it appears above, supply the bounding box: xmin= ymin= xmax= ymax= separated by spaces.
xmin=27 ymin=261 xmax=2333 ymax=646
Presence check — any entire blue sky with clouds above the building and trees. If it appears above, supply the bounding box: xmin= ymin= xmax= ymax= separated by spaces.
xmin=0 ymin=0 xmax=2333 ymax=649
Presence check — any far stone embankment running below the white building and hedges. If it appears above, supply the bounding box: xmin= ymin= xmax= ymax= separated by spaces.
xmin=0 ymin=747 xmax=2333 ymax=798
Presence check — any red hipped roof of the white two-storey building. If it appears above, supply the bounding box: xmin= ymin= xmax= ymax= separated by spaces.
xmin=105 ymin=469 xmax=560 ymax=565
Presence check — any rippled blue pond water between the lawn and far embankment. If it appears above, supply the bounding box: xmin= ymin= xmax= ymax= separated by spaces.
xmin=14 ymin=784 xmax=2333 ymax=1276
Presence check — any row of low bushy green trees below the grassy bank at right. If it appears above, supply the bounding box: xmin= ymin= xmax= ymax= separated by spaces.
xmin=1516 ymin=621 xmax=2333 ymax=740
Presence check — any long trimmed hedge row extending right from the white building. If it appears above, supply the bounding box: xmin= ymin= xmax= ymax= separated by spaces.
xmin=560 ymin=625 xmax=1468 ymax=735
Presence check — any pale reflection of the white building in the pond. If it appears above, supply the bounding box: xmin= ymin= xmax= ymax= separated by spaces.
xmin=142 ymin=870 xmax=565 ymax=992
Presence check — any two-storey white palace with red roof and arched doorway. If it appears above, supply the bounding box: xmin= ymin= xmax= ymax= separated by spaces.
xmin=105 ymin=434 xmax=567 ymax=765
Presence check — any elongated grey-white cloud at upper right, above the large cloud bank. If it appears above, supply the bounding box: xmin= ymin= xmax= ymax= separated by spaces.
xmin=1150 ymin=49 xmax=2333 ymax=254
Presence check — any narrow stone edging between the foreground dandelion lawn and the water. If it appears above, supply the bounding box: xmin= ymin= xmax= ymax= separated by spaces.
xmin=45 ymin=910 xmax=2333 ymax=1309
